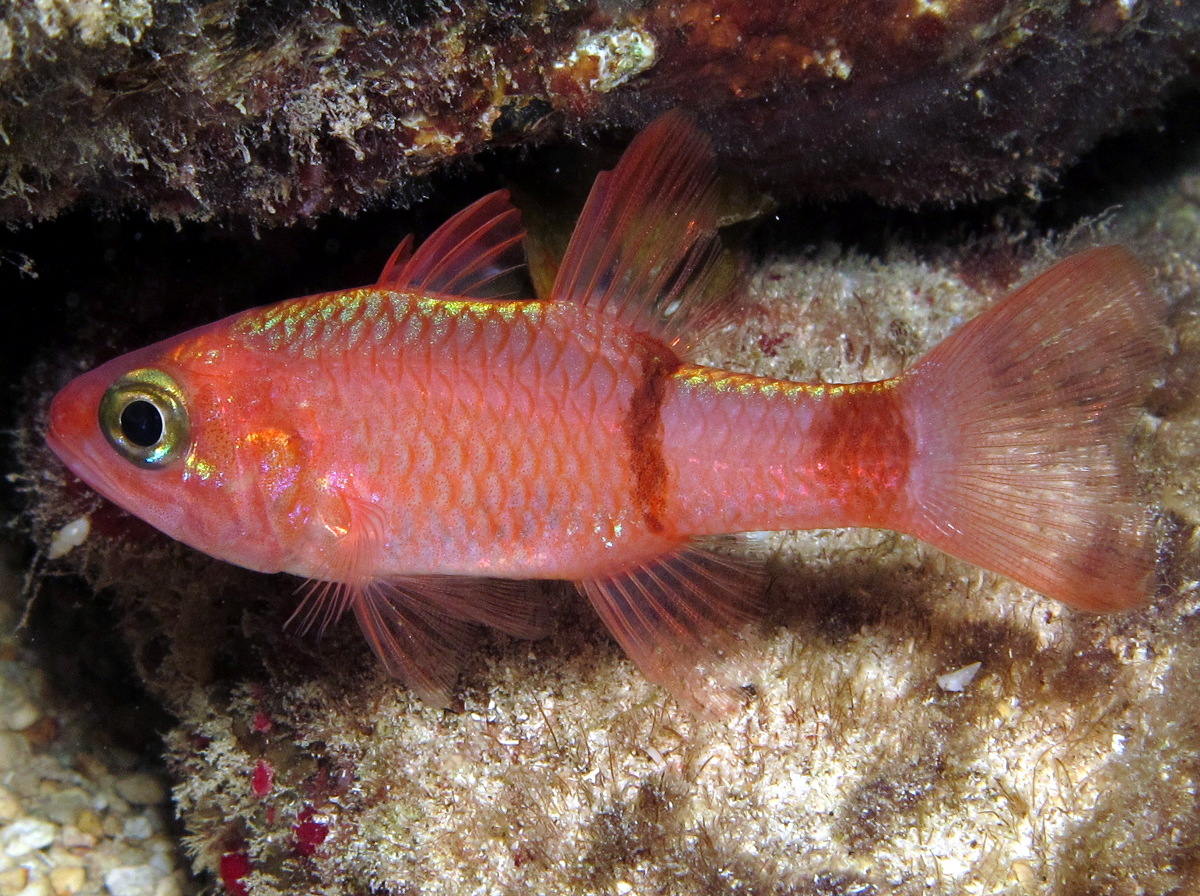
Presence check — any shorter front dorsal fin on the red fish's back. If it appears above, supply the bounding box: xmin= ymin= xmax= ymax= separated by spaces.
xmin=377 ymin=190 xmax=524 ymax=299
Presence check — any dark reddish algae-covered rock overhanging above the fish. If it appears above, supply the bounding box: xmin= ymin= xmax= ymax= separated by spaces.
xmin=0 ymin=0 xmax=1200 ymax=223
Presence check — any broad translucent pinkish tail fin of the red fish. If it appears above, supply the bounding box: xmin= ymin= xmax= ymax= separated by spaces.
xmin=902 ymin=246 xmax=1166 ymax=611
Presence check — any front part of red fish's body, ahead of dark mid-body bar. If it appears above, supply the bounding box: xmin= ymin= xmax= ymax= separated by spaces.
xmin=60 ymin=288 xmax=679 ymax=579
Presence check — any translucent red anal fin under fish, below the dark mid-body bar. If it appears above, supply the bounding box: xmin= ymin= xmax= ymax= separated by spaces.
xmin=577 ymin=545 xmax=763 ymax=717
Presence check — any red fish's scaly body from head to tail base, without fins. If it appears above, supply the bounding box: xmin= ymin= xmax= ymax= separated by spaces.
xmin=52 ymin=296 xmax=911 ymax=581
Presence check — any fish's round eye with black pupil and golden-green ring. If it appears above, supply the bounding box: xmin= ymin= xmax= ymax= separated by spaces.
xmin=100 ymin=368 xmax=187 ymax=467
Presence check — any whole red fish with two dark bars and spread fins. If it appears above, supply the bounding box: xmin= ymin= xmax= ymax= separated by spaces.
xmin=47 ymin=114 xmax=1165 ymax=711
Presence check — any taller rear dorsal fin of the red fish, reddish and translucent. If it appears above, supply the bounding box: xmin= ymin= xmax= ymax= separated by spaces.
xmin=553 ymin=112 xmax=740 ymax=353
